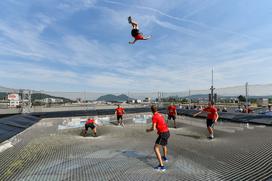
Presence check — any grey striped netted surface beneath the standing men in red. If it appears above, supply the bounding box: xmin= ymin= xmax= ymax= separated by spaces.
xmin=0 ymin=113 xmax=272 ymax=181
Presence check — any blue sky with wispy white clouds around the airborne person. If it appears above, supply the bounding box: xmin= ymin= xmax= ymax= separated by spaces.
xmin=0 ymin=0 xmax=272 ymax=92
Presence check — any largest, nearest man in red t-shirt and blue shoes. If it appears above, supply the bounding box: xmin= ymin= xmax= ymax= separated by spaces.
xmin=146 ymin=105 xmax=170 ymax=171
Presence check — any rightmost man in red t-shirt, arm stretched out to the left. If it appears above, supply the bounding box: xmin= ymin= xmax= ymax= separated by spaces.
xmin=193 ymin=102 xmax=219 ymax=139
